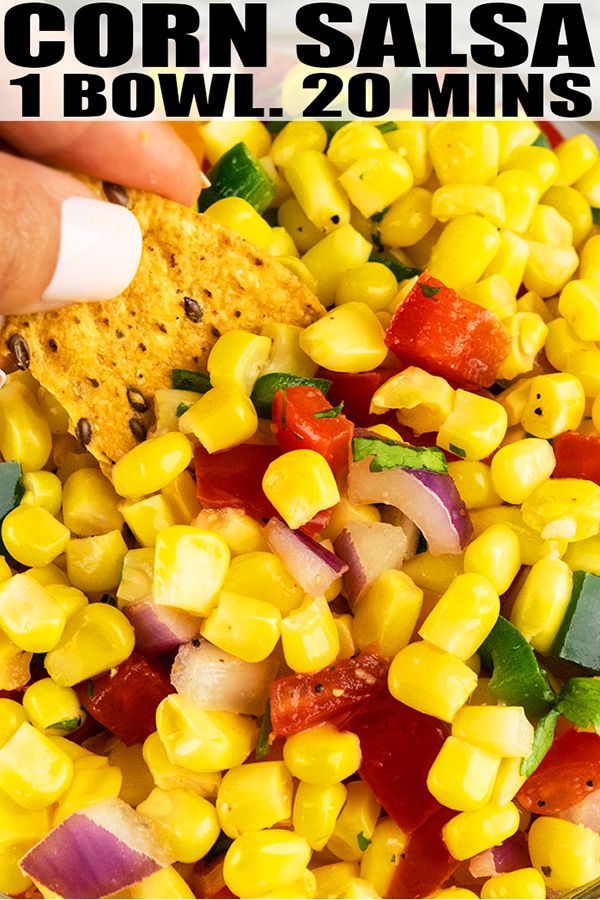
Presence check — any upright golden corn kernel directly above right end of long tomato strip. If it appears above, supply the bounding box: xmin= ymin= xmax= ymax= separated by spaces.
xmin=352 ymin=569 xmax=423 ymax=659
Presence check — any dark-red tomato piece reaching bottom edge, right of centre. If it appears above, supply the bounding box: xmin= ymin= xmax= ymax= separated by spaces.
xmin=387 ymin=806 xmax=458 ymax=897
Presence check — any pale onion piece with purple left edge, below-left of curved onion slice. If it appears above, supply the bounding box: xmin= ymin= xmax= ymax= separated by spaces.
xmin=334 ymin=522 xmax=406 ymax=607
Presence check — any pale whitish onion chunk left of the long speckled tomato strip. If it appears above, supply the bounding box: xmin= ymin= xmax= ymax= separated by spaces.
xmin=171 ymin=640 xmax=278 ymax=716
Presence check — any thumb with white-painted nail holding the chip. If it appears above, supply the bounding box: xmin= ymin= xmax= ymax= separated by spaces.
xmin=0 ymin=153 xmax=142 ymax=314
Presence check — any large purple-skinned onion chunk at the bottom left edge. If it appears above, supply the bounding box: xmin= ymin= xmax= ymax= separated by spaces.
xmin=20 ymin=798 xmax=174 ymax=898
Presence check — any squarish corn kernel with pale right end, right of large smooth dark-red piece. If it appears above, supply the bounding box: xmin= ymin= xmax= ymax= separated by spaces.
xmin=427 ymin=740 xmax=500 ymax=811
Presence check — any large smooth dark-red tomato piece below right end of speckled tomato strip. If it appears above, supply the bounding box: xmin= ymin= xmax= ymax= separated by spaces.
xmin=344 ymin=691 xmax=448 ymax=832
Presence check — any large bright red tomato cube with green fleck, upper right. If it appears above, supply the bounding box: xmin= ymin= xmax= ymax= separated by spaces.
xmin=385 ymin=272 xmax=510 ymax=387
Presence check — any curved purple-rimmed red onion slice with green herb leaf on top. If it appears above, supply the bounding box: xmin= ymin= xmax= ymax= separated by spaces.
xmin=350 ymin=457 xmax=473 ymax=556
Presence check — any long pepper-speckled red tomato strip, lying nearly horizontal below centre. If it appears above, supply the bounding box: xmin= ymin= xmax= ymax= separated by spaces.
xmin=271 ymin=652 xmax=388 ymax=736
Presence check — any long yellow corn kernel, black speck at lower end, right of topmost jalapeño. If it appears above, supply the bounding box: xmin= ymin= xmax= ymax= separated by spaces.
xmin=285 ymin=150 xmax=350 ymax=234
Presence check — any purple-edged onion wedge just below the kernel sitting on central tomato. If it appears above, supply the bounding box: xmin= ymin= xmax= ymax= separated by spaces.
xmin=264 ymin=518 xmax=348 ymax=597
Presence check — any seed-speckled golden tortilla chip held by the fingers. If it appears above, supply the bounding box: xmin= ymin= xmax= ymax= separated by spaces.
xmin=0 ymin=184 xmax=324 ymax=470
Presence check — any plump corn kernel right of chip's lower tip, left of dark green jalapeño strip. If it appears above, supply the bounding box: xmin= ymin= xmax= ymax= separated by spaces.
xmin=179 ymin=385 xmax=258 ymax=453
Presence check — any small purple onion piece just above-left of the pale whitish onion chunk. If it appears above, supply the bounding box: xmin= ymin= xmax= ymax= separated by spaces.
xmin=123 ymin=599 xmax=200 ymax=657
